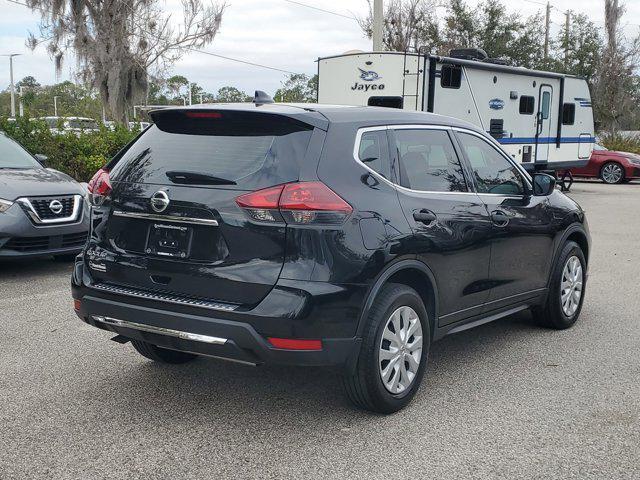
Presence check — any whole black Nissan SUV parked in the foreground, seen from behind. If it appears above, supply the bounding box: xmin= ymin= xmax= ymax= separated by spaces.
xmin=72 ymin=104 xmax=590 ymax=413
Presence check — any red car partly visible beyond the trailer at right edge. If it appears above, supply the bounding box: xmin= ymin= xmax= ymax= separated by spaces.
xmin=571 ymin=144 xmax=640 ymax=183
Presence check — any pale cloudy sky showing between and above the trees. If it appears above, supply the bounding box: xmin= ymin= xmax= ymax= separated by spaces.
xmin=0 ymin=0 xmax=640 ymax=93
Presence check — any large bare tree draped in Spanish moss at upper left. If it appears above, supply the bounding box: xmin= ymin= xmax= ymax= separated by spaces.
xmin=27 ymin=0 xmax=225 ymax=122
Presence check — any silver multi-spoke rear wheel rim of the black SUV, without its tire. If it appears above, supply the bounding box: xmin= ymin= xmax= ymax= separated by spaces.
xmin=378 ymin=306 xmax=422 ymax=394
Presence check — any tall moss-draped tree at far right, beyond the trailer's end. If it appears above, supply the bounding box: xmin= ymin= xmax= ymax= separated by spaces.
xmin=594 ymin=0 xmax=640 ymax=134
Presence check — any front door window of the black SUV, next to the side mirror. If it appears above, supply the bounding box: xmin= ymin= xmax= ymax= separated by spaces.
xmin=458 ymin=133 xmax=525 ymax=195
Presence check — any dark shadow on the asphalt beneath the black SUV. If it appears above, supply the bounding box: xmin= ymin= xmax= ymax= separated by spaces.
xmin=79 ymin=313 xmax=541 ymax=428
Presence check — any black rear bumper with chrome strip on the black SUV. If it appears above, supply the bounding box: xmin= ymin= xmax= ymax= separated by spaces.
xmin=72 ymin=257 xmax=366 ymax=367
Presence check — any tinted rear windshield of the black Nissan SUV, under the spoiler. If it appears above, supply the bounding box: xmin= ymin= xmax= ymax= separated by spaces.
xmin=111 ymin=111 xmax=313 ymax=189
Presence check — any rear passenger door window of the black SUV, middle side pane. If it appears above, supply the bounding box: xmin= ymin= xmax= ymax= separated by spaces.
xmin=395 ymin=129 xmax=467 ymax=192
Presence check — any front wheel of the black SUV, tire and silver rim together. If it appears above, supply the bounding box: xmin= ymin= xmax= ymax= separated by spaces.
xmin=533 ymin=242 xmax=587 ymax=330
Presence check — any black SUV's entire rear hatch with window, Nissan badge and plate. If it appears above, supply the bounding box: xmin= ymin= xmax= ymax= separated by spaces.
xmin=86 ymin=110 xmax=320 ymax=305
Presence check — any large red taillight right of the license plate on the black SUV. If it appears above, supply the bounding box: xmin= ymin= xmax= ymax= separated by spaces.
xmin=236 ymin=182 xmax=353 ymax=225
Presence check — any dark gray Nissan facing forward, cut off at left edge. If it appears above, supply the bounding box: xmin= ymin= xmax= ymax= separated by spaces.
xmin=0 ymin=132 xmax=89 ymax=260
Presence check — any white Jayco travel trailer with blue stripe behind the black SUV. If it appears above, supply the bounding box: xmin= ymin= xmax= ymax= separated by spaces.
xmin=318 ymin=49 xmax=595 ymax=170
